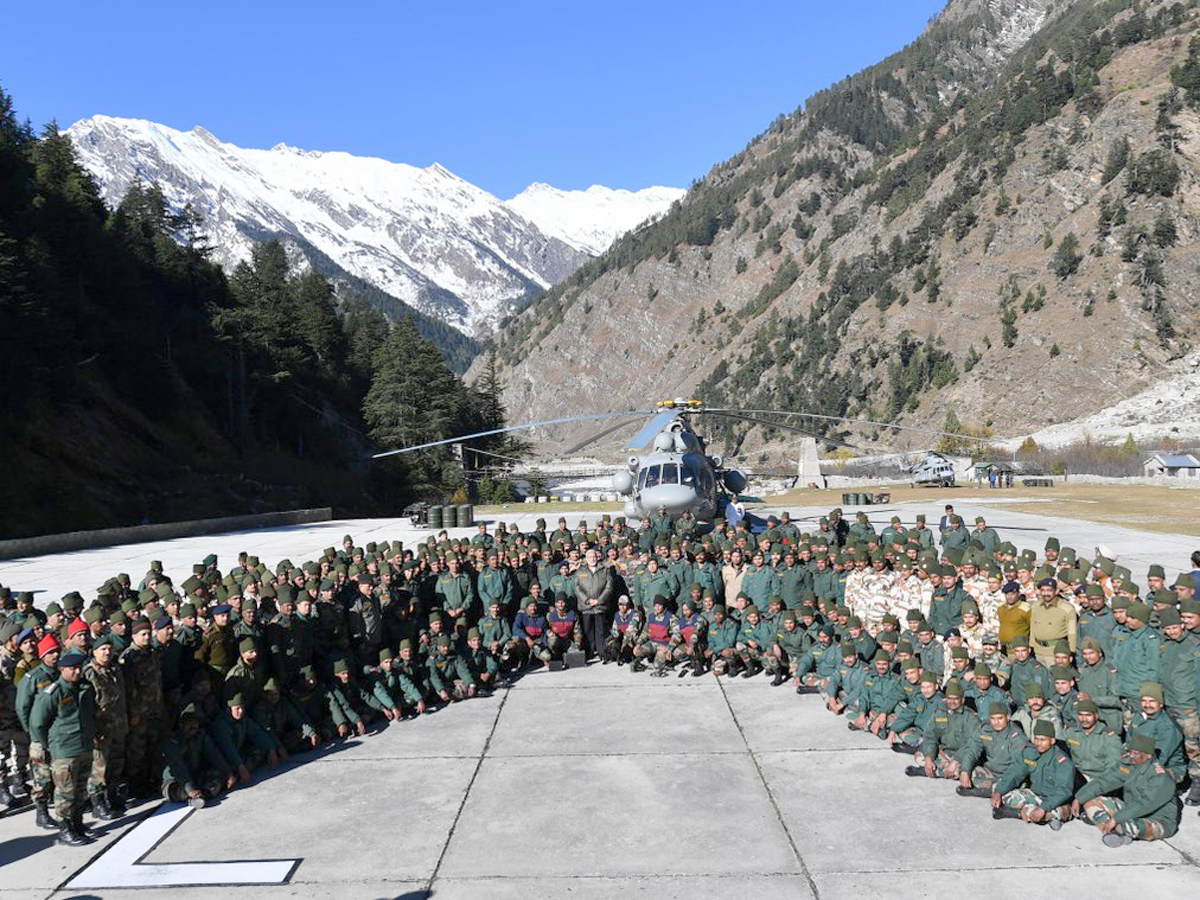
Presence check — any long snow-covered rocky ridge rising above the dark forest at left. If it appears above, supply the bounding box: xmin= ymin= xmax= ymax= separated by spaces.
xmin=67 ymin=115 xmax=673 ymax=334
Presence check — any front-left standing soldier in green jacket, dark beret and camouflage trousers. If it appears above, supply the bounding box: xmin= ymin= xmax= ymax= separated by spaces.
xmin=29 ymin=653 xmax=96 ymax=847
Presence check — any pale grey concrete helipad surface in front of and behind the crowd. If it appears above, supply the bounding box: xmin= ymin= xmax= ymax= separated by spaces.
xmin=0 ymin=504 xmax=1200 ymax=900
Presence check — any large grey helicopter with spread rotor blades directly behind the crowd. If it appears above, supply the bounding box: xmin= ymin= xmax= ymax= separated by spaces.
xmin=371 ymin=397 xmax=998 ymax=523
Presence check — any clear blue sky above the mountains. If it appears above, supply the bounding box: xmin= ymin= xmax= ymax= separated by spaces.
xmin=7 ymin=0 xmax=944 ymax=197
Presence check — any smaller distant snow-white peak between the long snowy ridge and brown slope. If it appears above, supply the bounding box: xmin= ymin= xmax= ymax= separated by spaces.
xmin=508 ymin=181 xmax=688 ymax=256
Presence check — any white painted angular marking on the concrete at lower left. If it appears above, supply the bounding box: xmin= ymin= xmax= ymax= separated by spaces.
xmin=61 ymin=803 xmax=301 ymax=890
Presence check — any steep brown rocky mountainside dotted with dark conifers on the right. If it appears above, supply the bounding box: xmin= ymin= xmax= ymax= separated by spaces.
xmin=477 ymin=0 xmax=1200 ymax=455
